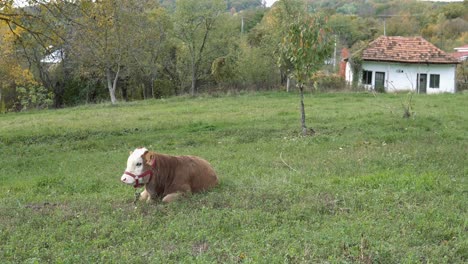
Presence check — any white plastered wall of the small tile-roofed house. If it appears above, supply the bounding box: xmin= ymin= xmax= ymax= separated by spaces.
xmin=345 ymin=61 xmax=456 ymax=94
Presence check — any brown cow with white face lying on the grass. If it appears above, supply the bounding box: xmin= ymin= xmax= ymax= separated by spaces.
xmin=120 ymin=148 xmax=218 ymax=202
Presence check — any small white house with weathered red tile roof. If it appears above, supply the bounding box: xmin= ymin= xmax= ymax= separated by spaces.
xmin=345 ymin=36 xmax=458 ymax=94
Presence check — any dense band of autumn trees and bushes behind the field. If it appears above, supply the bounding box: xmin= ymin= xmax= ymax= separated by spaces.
xmin=0 ymin=0 xmax=468 ymax=109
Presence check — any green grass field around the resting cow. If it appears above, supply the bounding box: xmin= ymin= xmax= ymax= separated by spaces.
xmin=0 ymin=92 xmax=468 ymax=263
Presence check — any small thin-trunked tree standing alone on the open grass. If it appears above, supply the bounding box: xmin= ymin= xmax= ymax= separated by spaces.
xmin=281 ymin=15 xmax=333 ymax=136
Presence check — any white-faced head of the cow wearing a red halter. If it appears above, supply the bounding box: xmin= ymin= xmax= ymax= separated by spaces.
xmin=120 ymin=148 xmax=153 ymax=188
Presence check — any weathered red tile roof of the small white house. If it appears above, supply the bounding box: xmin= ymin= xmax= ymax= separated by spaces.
xmin=362 ymin=36 xmax=457 ymax=64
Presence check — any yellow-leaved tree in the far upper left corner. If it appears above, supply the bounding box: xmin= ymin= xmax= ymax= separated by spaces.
xmin=0 ymin=0 xmax=73 ymax=107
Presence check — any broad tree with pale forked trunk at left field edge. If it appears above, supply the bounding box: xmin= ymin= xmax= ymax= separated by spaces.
xmin=71 ymin=0 xmax=155 ymax=104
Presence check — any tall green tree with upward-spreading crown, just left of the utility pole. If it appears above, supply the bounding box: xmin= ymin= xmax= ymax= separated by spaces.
xmin=175 ymin=0 xmax=226 ymax=96
